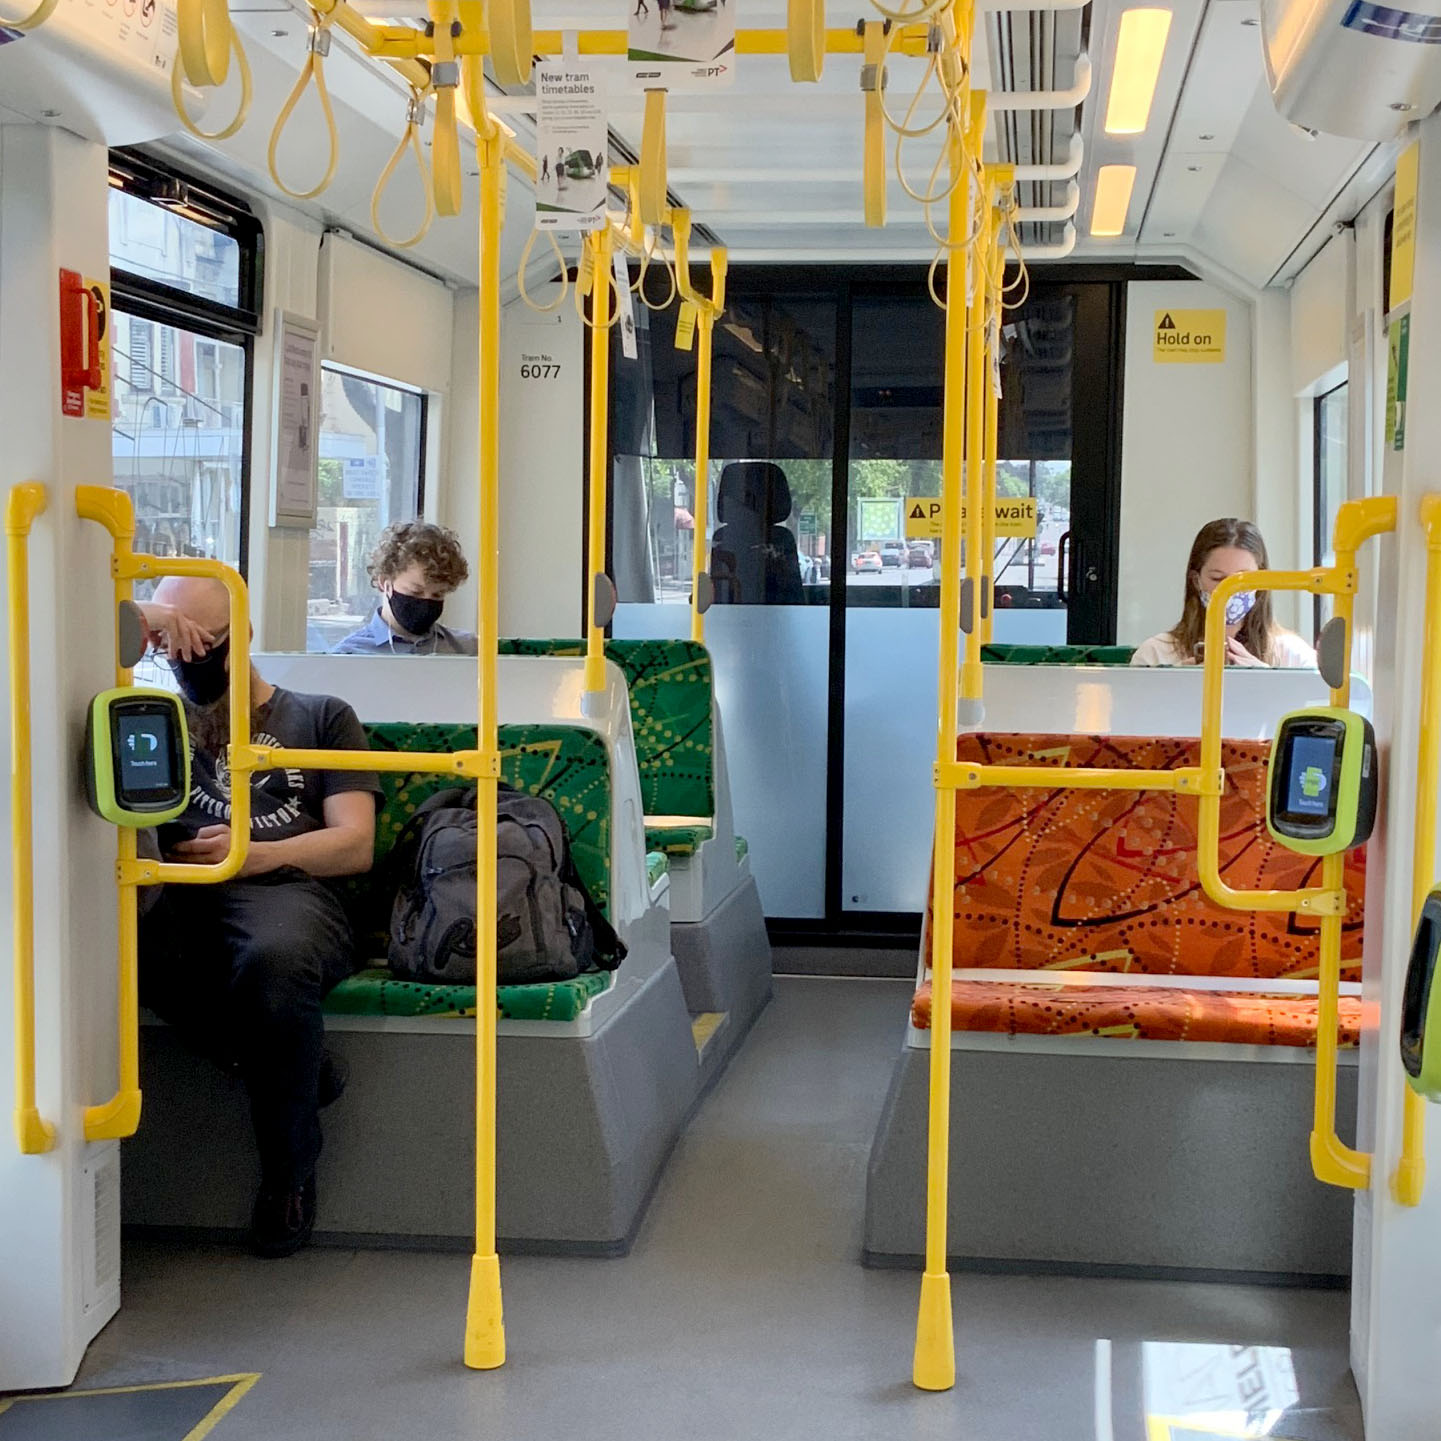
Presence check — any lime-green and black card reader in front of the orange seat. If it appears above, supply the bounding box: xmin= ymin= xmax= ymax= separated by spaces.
xmin=1265 ymin=706 xmax=1378 ymax=856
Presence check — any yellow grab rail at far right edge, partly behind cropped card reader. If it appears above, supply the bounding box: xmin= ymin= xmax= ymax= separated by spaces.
xmin=1391 ymin=496 xmax=1441 ymax=1206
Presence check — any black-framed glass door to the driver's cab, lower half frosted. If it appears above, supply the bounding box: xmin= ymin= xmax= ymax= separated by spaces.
xmin=611 ymin=276 xmax=1120 ymax=934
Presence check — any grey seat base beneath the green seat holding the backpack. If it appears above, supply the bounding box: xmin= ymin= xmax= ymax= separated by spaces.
xmin=121 ymin=957 xmax=700 ymax=1255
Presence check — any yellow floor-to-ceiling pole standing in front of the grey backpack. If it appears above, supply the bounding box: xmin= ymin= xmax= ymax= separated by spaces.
xmin=464 ymin=117 xmax=506 ymax=1370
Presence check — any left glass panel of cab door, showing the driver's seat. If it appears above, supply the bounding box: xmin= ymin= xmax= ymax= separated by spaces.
xmin=611 ymin=297 xmax=836 ymax=918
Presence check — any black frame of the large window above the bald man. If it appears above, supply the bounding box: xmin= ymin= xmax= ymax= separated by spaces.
xmin=110 ymin=150 xmax=265 ymax=575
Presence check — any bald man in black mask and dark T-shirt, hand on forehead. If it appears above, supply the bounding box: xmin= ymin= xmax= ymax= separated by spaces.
xmin=140 ymin=578 xmax=380 ymax=1257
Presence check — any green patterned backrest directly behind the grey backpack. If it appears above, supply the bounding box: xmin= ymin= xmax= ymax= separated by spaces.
xmin=365 ymin=722 xmax=612 ymax=915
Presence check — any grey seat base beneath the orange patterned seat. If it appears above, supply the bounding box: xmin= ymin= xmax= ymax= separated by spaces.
xmin=863 ymin=1038 xmax=1356 ymax=1284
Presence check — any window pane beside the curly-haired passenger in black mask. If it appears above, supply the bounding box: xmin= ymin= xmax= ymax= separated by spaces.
xmin=305 ymin=366 xmax=427 ymax=651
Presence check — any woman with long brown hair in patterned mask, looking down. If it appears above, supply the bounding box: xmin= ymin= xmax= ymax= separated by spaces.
xmin=1131 ymin=516 xmax=1316 ymax=669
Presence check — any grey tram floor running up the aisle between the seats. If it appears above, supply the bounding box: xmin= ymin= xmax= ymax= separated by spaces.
xmin=59 ymin=978 xmax=1362 ymax=1441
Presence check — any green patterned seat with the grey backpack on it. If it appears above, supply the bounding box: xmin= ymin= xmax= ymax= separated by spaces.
xmin=326 ymin=722 xmax=611 ymax=1020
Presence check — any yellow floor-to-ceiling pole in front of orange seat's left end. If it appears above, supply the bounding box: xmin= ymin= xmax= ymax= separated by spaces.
xmin=911 ymin=123 xmax=970 ymax=1391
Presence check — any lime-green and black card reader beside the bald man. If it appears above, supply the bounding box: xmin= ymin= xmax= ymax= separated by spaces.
xmin=85 ymin=686 xmax=190 ymax=826
